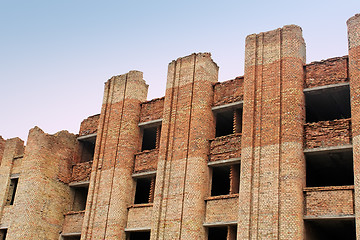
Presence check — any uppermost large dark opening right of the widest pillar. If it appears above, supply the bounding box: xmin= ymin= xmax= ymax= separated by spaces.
xmin=305 ymin=85 xmax=351 ymax=123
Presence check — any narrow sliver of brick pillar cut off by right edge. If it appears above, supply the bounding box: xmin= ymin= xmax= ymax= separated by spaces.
xmin=347 ymin=14 xmax=360 ymax=238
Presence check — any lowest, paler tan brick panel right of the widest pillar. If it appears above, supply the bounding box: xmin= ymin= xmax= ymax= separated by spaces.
xmin=304 ymin=186 xmax=354 ymax=217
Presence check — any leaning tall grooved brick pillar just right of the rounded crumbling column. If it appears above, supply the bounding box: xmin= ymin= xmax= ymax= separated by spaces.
xmin=81 ymin=71 xmax=148 ymax=240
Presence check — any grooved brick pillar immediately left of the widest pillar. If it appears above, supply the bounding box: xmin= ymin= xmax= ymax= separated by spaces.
xmin=151 ymin=53 xmax=218 ymax=240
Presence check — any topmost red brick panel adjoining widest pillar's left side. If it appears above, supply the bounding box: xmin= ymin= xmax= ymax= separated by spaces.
xmin=214 ymin=77 xmax=244 ymax=106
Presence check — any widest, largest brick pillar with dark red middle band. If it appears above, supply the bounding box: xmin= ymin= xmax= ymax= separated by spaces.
xmin=238 ymin=25 xmax=305 ymax=240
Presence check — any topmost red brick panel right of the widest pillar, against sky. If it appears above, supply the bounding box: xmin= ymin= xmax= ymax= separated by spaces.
xmin=305 ymin=56 xmax=349 ymax=88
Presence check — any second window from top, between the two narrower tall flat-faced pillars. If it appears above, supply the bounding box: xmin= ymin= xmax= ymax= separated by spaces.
xmin=134 ymin=177 xmax=155 ymax=204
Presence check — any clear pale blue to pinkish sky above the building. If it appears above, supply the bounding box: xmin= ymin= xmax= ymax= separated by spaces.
xmin=0 ymin=0 xmax=360 ymax=140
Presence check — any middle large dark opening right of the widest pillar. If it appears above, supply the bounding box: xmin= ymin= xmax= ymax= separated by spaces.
xmin=305 ymin=150 xmax=354 ymax=187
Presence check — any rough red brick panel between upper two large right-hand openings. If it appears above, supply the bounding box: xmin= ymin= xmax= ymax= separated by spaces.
xmin=304 ymin=118 xmax=351 ymax=148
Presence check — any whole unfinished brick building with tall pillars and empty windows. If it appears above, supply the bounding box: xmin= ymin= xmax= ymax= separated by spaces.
xmin=0 ymin=15 xmax=360 ymax=240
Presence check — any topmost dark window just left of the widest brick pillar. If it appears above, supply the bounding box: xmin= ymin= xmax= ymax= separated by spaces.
xmin=215 ymin=108 xmax=242 ymax=137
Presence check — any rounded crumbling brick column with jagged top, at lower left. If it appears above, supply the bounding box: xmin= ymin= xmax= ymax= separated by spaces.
xmin=6 ymin=127 xmax=77 ymax=239
